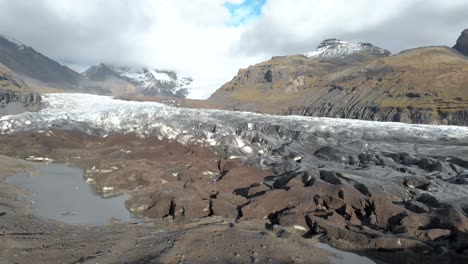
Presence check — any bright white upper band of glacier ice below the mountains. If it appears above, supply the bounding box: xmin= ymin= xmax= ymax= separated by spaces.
xmin=0 ymin=93 xmax=468 ymax=155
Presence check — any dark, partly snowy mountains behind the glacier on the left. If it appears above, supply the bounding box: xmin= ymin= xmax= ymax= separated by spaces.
xmin=0 ymin=36 xmax=193 ymax=98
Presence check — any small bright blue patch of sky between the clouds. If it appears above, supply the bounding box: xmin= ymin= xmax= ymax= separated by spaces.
xmin=224 ymin=0 xmax=266 ymax=26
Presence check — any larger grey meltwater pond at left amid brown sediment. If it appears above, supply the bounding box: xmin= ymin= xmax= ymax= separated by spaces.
xmin=7 ymin=163 xmax=137 ymax=225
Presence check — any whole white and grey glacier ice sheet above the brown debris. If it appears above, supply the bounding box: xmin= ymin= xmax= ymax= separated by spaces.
xmin=0 ymin=93 xmax=468 ymax=208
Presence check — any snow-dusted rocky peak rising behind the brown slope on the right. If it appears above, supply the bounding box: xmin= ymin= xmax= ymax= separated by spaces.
xmin=304 ymin=39 xmax=390 ymax=58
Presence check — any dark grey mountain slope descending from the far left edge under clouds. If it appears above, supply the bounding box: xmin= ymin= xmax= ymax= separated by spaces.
xmin=0 ymin=36 xmax=83 ymax=89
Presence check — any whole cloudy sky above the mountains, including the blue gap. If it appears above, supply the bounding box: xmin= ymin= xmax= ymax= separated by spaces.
xmin=0 ymin=0 xmax=468 ymax=98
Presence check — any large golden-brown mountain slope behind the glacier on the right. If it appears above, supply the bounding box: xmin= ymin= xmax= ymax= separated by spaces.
xmin=209 ymin=47 xmax=468 ymax=125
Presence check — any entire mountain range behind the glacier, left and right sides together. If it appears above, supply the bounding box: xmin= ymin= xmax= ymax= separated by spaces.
xmin=0 ymin=30 xmax=468 ymax=125
